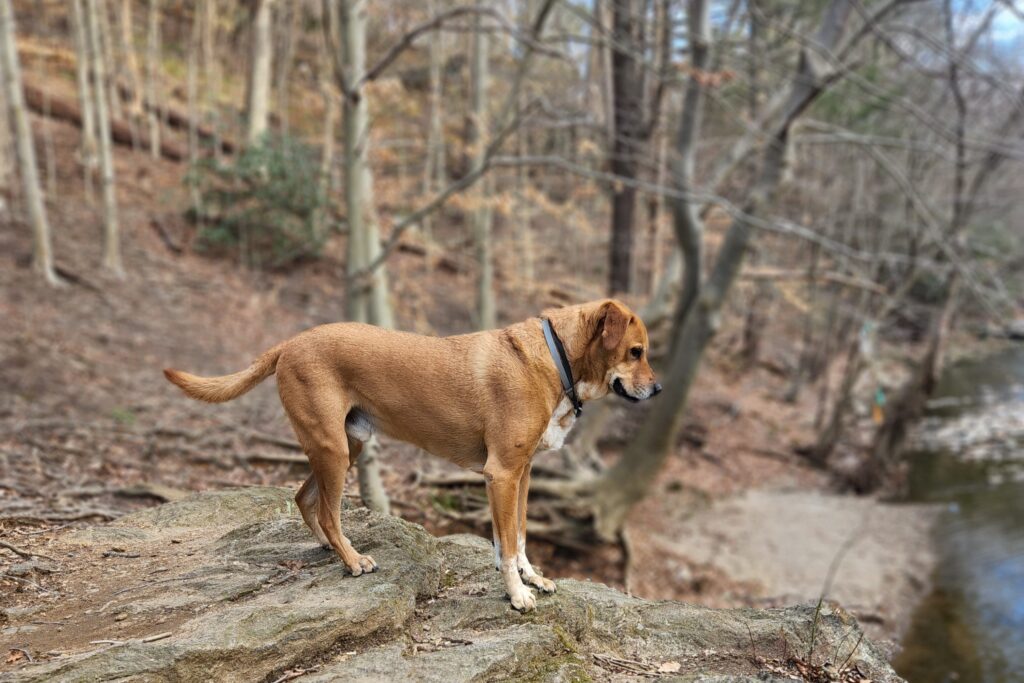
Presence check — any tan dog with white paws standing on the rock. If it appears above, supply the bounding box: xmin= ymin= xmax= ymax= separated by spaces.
xmin=164 ymin=299 xmax=662 ymax=610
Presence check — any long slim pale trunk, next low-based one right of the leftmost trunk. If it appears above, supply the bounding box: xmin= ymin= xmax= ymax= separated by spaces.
xmin=85 ymin=0 xmax=124 ymax=276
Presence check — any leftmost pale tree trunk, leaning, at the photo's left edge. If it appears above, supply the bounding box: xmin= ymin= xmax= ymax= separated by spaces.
xmin=0 ymin=2 xmax=58 ymax=285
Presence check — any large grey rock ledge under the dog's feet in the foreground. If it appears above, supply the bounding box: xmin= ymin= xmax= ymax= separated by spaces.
xmin=0 ymin=488 xmax=900 ymax=683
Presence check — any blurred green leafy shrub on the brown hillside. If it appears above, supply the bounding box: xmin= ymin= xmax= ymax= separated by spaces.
xmin=186 ymin=135 xmax=327 ymax=267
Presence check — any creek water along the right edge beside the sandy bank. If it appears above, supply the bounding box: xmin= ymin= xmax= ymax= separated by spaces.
xmin=894 ymin=345 xmax=1024 ymax=683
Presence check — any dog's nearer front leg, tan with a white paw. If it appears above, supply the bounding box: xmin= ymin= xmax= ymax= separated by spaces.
xmin=483 ymin=457 xmax=537 ymax=611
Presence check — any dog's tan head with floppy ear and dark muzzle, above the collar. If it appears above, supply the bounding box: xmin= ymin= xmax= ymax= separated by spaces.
xmin=545 ymin=299 xmax=662 ymax=401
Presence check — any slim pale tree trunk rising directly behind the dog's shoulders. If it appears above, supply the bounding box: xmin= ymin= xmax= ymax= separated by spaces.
xmin=467 ymin=0 xmax=498 ymax=330
